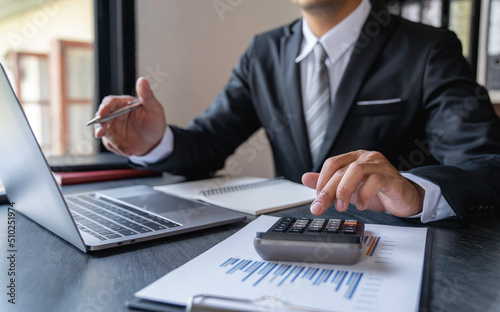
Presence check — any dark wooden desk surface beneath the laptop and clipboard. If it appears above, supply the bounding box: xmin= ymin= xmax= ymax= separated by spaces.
xmin=0 ymin=177 xmax=500 ymax=312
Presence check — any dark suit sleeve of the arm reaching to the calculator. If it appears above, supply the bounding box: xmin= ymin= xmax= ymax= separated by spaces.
xmin=410 ymin=32 xmax=500 ymax=223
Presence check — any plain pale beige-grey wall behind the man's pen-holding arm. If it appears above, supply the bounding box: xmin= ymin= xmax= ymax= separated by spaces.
xmin=135 ymin=0 xmax=300 ymax=177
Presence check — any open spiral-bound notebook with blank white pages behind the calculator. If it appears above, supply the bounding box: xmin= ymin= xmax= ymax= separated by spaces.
xmin=154 ymin=177 xmax=316 ymax=215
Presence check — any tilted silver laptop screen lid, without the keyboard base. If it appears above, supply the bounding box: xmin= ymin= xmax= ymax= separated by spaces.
xmin=0 ymin=66 xmax=85 ymax=251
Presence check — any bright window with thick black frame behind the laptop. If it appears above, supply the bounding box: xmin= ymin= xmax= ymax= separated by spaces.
xmin=0 ymin=0 xmax=136 ymax=161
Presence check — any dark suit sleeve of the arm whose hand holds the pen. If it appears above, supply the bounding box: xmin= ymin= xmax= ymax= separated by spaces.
xmin=137 ymin=39 xmax=261 ymax=177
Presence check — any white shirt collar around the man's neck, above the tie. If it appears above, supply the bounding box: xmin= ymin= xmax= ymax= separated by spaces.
xmin=295 ymin=0 xmax=372 ymax=63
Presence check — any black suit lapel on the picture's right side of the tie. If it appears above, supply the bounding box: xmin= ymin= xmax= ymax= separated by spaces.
xmin=313 ymin=6 xmax=395 ymax=171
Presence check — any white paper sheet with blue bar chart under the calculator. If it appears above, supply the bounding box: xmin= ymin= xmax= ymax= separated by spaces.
xmin=135 ymin=216 xmax=427 ymax=311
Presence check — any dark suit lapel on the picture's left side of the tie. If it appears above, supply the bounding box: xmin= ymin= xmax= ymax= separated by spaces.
xmin=280 ymin=20 xmax=312 ymax=172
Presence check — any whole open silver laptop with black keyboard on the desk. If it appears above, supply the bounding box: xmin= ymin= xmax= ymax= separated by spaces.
xmin=0 ymin=64 xmax=245 ymax=252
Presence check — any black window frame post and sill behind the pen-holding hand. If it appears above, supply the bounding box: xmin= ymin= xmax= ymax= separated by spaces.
xmin=48 ymin=0 xmax=136 ymax=172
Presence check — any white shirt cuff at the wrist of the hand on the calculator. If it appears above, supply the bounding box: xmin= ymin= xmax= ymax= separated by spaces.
xmin=401 ymin=172 xmax=457 ymax=223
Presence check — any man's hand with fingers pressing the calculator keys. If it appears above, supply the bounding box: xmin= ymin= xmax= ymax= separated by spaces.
xmin=302 ymin=150 xmax=425 ymax=217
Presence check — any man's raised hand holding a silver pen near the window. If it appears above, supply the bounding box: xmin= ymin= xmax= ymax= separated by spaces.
xmin=94 ymin=77 xmax=167 ymax=157
